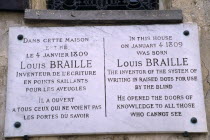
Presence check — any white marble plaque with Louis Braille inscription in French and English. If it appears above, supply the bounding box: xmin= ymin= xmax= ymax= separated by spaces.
xmin=5 ymin=24 xmax=207 ymax=137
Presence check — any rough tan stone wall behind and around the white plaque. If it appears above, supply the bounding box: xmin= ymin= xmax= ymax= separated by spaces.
xmin=0 ymin=0 xmax=210 ymax=140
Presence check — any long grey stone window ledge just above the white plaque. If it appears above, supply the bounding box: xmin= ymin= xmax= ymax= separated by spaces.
xmin=24 ymin=9 xmax=183 ymax=24
